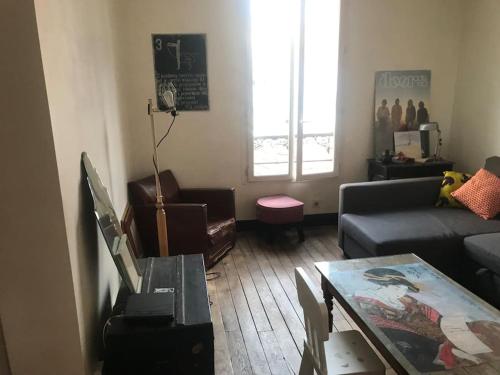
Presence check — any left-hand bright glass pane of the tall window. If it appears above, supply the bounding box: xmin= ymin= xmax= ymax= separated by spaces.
xmin=251 ymin=0 xmax=296 ymax=176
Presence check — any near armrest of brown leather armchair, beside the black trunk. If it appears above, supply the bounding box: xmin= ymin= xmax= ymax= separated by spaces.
xmin=164 ymin=203 xmax=208 ymax=253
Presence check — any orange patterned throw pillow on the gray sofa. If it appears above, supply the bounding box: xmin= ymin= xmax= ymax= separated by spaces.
xmin=451 ymin=168 xmax=500 ymax=220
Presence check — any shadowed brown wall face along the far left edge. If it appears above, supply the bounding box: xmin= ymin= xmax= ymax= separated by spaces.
xmin=0 ymin=0 xmax=84 ymax=375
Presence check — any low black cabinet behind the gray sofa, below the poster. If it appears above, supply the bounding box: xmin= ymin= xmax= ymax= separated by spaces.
xmin=368 ymin=159 xmax=454 ymax=181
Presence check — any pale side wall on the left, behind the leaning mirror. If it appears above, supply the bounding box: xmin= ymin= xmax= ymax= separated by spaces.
xmin=35 ymin=0 xmax=127 ymax=372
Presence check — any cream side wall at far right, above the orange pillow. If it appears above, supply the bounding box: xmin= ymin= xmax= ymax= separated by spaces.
xmin=451 ymin=0 xmax=500 ymax=173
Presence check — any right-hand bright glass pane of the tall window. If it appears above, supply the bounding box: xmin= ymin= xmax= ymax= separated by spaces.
xmin=302 ymin=0 xmax=340 ymax=175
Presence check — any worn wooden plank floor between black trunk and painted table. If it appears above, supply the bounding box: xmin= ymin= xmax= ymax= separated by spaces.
xmin=208 ymin=226 xmax=394 ymax=375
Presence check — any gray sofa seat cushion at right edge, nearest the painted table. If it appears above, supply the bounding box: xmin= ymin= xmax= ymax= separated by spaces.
xmin=464 ymin=233 xmax=500 ymax=275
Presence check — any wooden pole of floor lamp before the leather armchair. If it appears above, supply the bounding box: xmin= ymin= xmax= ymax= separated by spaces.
xmin=148 ymin=99 xmax=169 ymax=256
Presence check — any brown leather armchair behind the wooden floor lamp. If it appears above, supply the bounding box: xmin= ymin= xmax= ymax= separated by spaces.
xmin=128 ymin=170 xmax=236 ymax=268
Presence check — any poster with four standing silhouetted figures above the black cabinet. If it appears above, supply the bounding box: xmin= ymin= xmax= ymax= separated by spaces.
xmin=374 ymin=70 xmax=431 ymax=156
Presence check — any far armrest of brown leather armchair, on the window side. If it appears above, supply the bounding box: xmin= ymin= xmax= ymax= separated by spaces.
xmin=180 ymin=188 xmax=236 ymax=218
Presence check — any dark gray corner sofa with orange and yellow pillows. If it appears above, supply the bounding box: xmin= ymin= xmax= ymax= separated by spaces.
xmin=338 ymin=157 xmax=500 ymax=306
